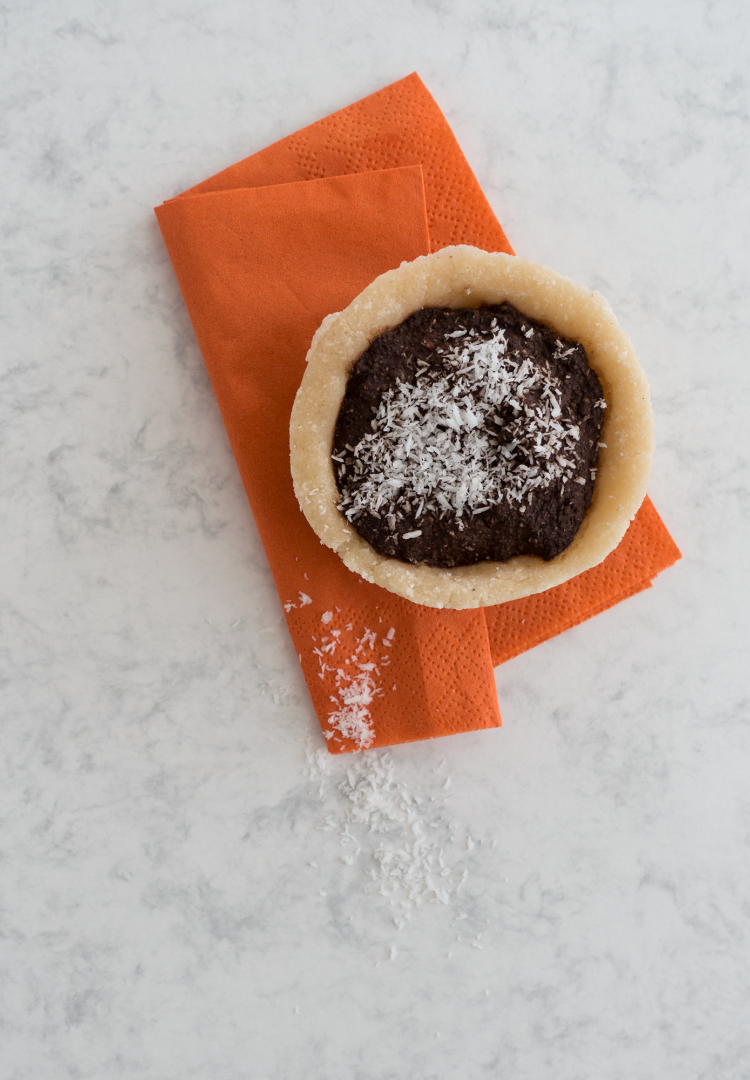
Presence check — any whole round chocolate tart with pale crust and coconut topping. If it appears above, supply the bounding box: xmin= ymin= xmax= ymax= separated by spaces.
xmin=291 ymin=246 xmax=654 ymax=608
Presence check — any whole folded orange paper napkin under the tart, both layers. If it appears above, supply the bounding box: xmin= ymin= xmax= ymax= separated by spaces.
xmin=156 ymin=75 xmax=680 ymax=753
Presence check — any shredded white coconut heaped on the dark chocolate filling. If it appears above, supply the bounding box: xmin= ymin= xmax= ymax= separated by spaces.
xmin=334 ymin=321 xmax=603 ymax=527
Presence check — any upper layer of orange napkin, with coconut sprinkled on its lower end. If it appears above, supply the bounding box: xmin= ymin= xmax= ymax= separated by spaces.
xmin=157 ymin=165 xmax=500 ymax=752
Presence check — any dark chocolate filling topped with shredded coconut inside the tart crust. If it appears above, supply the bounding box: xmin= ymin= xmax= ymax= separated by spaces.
xmin=332 ymin=303 xmax=606 ymax=567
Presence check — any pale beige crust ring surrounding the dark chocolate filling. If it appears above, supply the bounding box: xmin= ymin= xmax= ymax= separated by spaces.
xmin=291 ymin=245 xmax=654 ymax=608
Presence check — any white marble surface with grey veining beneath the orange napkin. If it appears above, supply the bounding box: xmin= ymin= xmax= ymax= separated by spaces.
xmin=0 ymin=0 xmax=750 ymax=1080
